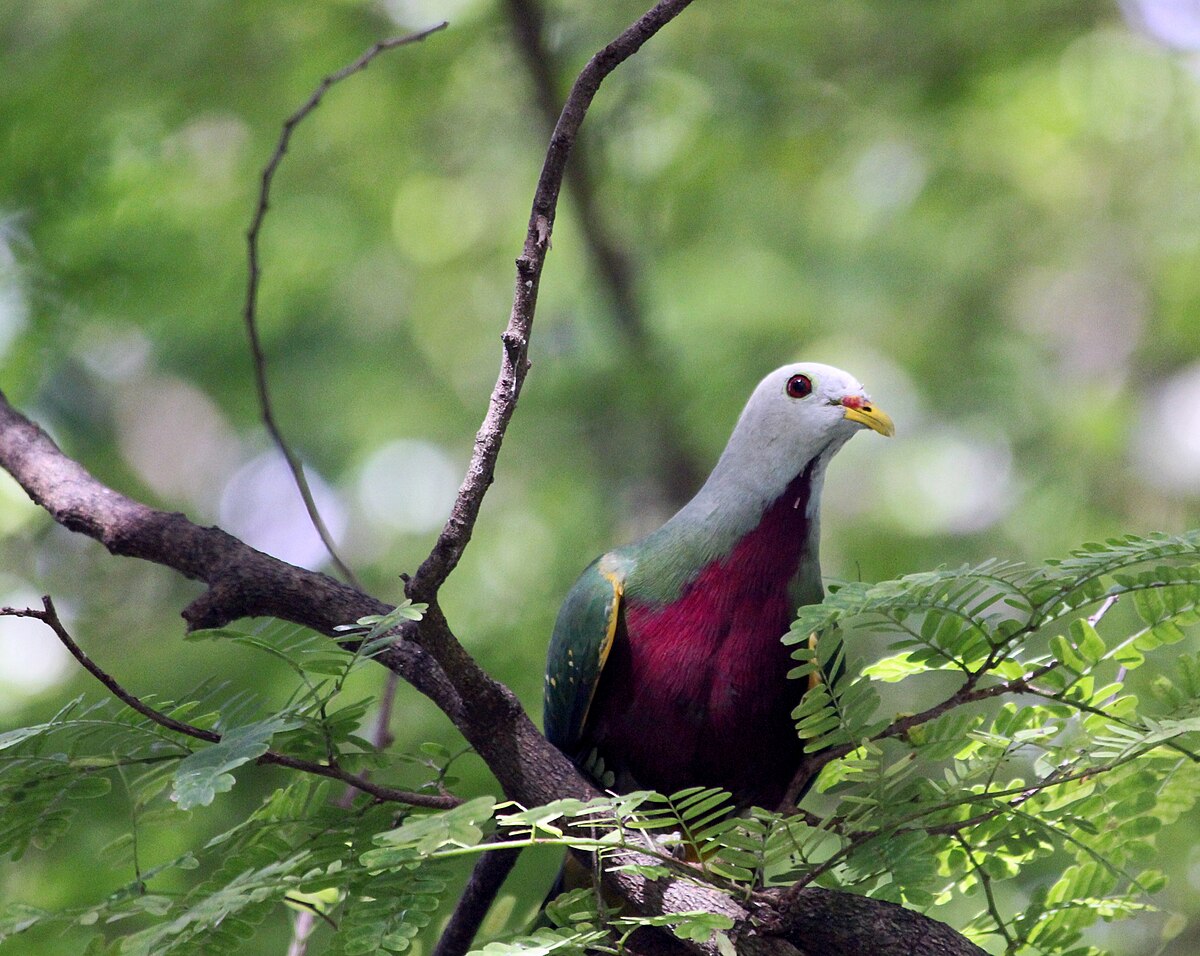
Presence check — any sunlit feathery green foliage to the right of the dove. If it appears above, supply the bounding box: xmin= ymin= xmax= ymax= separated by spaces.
xmin=768 ymin=533 xmax=1200 ymax=954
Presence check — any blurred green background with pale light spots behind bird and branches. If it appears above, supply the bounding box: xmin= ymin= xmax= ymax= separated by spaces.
xmin=0 ymin=0 xmax=1200 ymax=956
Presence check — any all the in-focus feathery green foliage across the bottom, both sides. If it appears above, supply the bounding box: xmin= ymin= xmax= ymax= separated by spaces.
xmin=0 ymin=533 xmax=1200 ymax=956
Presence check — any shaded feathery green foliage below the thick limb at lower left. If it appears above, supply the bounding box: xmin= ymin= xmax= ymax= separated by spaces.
xmin=0 ymin=623 xmax=463 ymax=955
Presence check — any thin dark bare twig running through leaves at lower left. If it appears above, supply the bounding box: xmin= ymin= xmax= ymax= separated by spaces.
xmin=0 ymin=595 xmax=462 ymax=810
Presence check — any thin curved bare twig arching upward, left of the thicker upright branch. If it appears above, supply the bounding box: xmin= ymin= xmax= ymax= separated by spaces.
xmin=242 ymin=20 xmax=446 ymax=590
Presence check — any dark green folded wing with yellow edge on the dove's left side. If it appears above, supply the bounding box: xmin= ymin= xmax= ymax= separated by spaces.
xmin=542 ymin=554 xmax=625 ymax=757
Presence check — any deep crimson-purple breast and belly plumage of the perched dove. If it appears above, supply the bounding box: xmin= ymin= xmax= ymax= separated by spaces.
xmin=590 ymin=470 xmax=811 ymax=805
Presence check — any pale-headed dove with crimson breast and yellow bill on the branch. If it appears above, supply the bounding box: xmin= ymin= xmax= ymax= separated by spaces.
xmin=542 ymin=362 xmax=895 ymax=810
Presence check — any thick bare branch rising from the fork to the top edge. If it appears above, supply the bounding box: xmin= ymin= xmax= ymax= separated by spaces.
xmin=408 ymin=0 xmax=691 ymax=602
